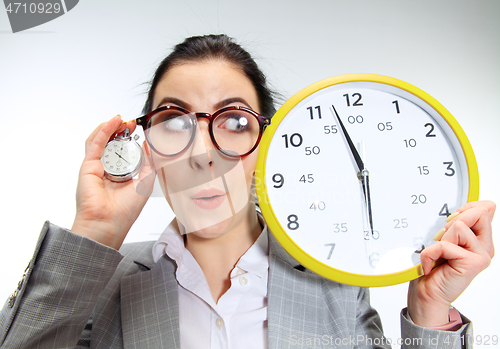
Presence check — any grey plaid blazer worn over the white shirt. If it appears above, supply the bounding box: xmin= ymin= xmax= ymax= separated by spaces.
xmin=0 ymin=222 xmax=472 ymax=349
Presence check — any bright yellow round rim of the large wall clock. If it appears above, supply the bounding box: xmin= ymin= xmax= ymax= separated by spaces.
xmin=255 ymin=74 xmax=479 ymax=287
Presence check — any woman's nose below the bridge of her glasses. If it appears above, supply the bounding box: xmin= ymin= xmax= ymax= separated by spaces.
xmin=189 ymin=116 xmax=215 ymax=170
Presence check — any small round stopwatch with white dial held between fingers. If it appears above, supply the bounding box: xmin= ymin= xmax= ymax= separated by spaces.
xmin=101 ymin=140 xmax=142 ymax=176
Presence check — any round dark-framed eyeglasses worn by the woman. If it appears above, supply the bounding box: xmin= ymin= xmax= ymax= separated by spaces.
xmin=135 ymin=105 xmax=271 ymax=157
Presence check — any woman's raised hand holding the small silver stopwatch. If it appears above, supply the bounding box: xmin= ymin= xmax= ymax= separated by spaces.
xmin=71 ymin=116 xmax=154 ymax=249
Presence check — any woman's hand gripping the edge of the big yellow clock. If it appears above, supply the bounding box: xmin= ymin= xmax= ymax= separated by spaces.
xmin=408 ymin=201 xmax=495 ymax=327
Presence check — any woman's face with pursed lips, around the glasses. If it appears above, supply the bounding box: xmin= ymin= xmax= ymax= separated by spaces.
xmin=150 ymin=60 xmax=259 ymax=238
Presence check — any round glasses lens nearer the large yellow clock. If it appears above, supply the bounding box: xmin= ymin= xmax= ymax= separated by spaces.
xmin=212 ymin=110 xmax=260 ymax=155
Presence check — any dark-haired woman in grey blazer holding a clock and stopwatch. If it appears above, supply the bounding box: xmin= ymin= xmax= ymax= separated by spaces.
xmin=0 ymin=35 xmax=495 ymax=348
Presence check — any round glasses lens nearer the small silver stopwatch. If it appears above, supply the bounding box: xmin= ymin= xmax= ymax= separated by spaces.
xmin=147 ymin=109 xmax=195 ymax=155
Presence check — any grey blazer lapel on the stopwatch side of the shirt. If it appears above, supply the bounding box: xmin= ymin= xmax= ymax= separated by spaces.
xmin=120 ymin=257 xmax=180 ymax=348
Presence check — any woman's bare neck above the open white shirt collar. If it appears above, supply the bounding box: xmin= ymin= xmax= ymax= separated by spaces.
xmin=185 ymin=205 xmax=262 ymax=302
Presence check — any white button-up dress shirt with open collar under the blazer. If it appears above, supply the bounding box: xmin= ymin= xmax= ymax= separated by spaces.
xmin=153 ymin=217 xmax=269 ymax=349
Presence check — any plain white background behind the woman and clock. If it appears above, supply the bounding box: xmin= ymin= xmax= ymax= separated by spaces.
xmin=0 ymin=0 xmax=500 ymax=348
